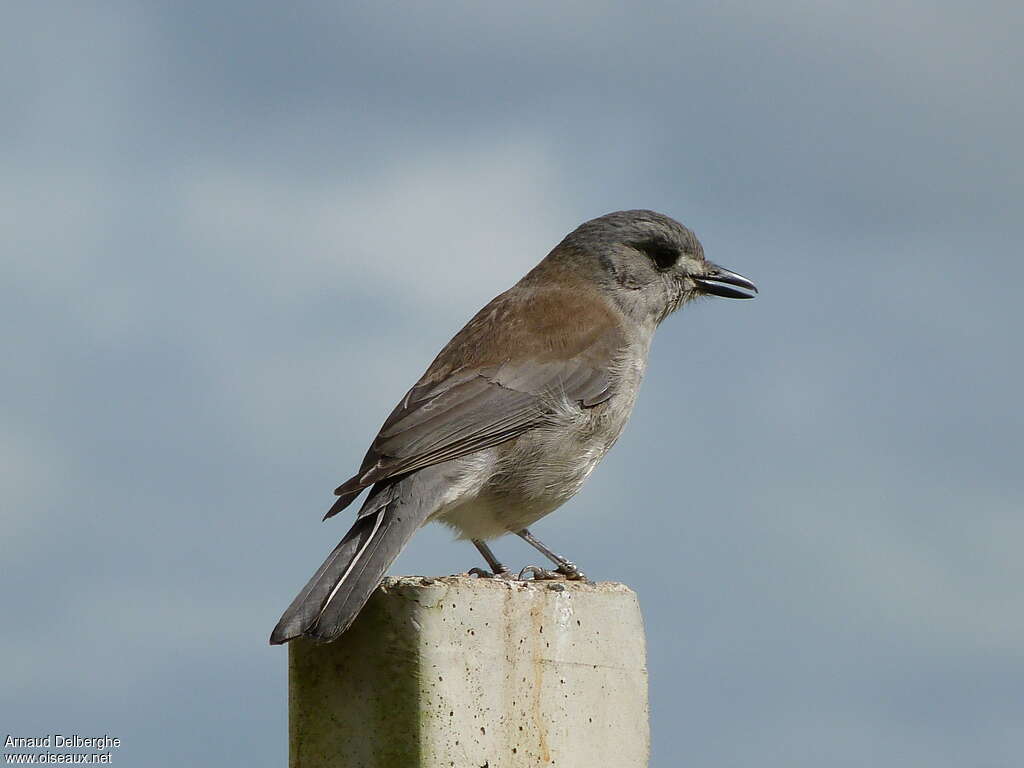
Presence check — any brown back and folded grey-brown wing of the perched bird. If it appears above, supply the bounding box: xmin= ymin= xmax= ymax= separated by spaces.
xmin=326 ymin=288 xmax=624 ymax=517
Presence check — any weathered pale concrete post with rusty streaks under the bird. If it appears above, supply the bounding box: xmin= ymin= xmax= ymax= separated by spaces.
xmin=288 ymin=577 xmax=649 ymax=768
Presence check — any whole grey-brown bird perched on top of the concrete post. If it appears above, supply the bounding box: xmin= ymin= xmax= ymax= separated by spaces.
xmin=270 ymin=210 xmax=757 ymax=644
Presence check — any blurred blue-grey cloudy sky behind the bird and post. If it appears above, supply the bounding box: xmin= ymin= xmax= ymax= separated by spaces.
xmin=0 ymin=0 xmax=1024 ymax=768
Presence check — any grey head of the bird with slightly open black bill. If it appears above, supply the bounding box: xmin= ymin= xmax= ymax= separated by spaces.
xmin=548 ymin=210 xmax=758 ymax=324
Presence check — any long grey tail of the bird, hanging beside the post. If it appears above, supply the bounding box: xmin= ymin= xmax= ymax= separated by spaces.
xmin=270 ymin=470 xmax=434 ymax=645
